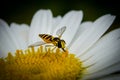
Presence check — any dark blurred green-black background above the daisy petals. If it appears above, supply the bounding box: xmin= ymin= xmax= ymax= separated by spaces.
xmin=0 ymin=0 xmax=120 ymax=29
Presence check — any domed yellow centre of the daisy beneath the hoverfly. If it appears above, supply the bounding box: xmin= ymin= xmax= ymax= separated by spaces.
xmin=0 ymin=46 xmax=85 ymax=80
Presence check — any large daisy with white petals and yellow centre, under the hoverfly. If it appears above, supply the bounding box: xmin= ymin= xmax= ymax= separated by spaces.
xmin=0 ymin=10 xmax=120 ymax=80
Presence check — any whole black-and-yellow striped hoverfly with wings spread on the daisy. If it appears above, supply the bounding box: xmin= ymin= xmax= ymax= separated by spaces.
xmin=29 ymin=26 xmax=66 ymax=52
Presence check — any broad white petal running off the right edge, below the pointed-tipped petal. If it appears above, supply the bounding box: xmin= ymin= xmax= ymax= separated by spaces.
xmin=80 ymin=29 xmax=120 ymax=73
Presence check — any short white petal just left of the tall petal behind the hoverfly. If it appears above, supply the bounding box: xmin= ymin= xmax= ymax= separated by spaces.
xmin=10 ymin=23 xmax=29 ymax=49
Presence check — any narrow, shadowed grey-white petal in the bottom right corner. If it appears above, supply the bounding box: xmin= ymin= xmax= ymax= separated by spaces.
xmin=84 ymin=63 xmax=120 ymax=80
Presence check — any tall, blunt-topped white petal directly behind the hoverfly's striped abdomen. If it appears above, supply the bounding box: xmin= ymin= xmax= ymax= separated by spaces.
xmin=29 ymin=10 xmax=52 ymax=44
